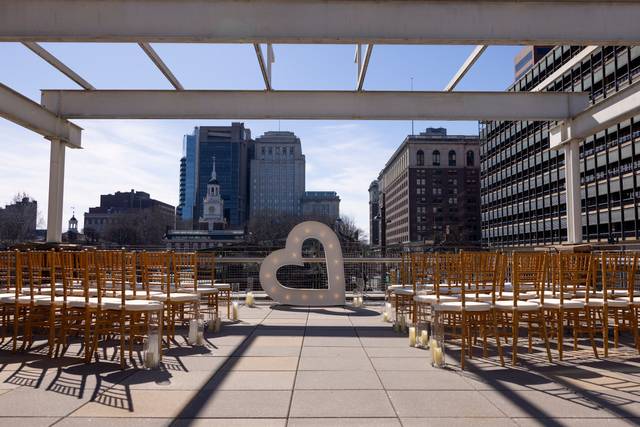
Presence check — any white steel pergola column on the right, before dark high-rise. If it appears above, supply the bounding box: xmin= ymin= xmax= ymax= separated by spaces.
xmin=563 ymin=140 xmax=582 ymax=244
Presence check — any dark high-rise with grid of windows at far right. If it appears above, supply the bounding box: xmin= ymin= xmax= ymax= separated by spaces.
xmin=480 ymin=46 xmax=640 ymax=246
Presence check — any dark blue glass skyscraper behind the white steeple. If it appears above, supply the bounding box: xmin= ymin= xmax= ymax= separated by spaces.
xmin=178 ymin=123 xmax=252 ymax=229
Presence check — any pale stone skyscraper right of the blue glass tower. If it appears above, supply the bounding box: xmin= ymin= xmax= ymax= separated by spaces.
xmin=249 ymin=131 xmax=305 ymax=217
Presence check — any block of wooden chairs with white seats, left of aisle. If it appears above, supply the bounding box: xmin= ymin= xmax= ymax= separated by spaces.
xmin=0 ymin=251 xmax=230 ymax=366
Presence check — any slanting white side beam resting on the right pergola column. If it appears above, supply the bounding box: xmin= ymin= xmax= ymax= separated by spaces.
xmin=539 ymin=83 xmax=640 ymax=149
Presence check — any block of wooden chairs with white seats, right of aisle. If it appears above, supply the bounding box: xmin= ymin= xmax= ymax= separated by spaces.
xmin=391 ymin=252 xmax=640 ymax=367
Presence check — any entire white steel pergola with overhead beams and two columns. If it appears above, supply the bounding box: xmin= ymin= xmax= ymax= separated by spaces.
xmin=0 ymin=0 xmax=640 ymax=243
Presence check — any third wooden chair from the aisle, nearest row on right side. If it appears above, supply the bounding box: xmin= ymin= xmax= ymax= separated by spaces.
xmin=531 ymin=253 xmax=598 ymax=360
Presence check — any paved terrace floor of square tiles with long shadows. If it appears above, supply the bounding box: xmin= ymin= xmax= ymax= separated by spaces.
xmin=0 ymin=305 xmax=640 ymax=427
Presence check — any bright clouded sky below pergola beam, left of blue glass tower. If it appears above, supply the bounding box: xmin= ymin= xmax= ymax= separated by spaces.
xmin=0 ymin=121 xmax=181 ymax=230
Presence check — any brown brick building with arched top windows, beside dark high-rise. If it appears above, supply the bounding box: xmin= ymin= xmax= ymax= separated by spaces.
xmin=372 ymin=128 xmax=480 ymax=245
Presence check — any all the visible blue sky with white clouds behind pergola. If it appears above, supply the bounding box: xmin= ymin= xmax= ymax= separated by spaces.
xmin=0 ymin=43 xmax=520 ymax=236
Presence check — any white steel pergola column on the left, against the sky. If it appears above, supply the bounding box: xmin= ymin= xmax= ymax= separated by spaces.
xmin=47 ymin=139 xmax=65 ymax=243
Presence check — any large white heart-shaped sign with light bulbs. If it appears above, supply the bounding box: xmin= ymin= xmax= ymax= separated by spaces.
xmin=260 ymin=221 xmax=345 ymax=306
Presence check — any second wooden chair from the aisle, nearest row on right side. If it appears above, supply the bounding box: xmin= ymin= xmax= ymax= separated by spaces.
xmin=494 ymin=252 xmax=552 ymax=365
